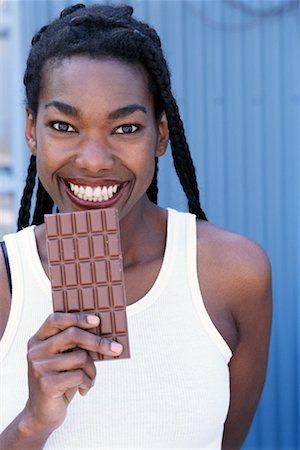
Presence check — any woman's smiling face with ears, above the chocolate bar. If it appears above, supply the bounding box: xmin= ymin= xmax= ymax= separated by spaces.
xmin=26 ymin=56 xmax=168 ymax=218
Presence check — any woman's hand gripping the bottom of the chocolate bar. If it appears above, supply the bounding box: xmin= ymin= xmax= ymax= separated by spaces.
xmin=23 ymin=313 xmax=122 ymax=433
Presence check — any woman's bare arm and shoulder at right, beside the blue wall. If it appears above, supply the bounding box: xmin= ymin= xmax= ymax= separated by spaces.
xmin=198 ymin=221 xmax=272 ymax=450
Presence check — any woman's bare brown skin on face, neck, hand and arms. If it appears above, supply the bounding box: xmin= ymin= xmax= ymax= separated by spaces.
xmin=0 ymin=57 xmax=271 ymax=450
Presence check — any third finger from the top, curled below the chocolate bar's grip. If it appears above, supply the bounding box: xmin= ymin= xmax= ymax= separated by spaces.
xmin=31 ymin=350 xmax=96 ymax=381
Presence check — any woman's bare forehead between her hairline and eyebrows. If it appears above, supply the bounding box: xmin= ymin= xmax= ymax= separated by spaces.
xmin=39 ymin=56 xmax=153 ymax=109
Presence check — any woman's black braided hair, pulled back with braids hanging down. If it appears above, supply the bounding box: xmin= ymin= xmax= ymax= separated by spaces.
xmin=18 ymin=3 xmax=207 ymax=230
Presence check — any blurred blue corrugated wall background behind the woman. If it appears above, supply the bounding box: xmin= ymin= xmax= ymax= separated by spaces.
xmin=0 ymin=0 xmax=300 ymax=450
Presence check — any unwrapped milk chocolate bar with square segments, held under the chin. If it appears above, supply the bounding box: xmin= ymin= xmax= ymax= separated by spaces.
xmin=45 ymin=208 xmax=130 ymax=360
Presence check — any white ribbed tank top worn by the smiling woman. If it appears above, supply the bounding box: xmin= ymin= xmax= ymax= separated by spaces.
xmin=0 ymin=209 xmax=231 ymax=450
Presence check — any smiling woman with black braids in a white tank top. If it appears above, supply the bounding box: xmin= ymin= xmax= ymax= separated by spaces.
xmin=0 ymin=4 xmax=271 ymax=450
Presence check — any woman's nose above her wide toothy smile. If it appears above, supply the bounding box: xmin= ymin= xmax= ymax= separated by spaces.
xmin=76 ymin=139 xmax=115 ymax=173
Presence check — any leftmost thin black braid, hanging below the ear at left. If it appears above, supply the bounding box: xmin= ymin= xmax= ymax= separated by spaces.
xmin=17 ymin=155 xmax=36 ymax=231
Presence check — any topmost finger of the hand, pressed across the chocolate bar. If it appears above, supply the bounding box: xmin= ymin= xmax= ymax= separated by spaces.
xmin=34 ymin=313 xmax=100 ymax=340
